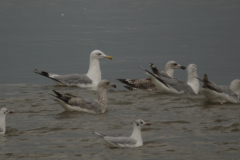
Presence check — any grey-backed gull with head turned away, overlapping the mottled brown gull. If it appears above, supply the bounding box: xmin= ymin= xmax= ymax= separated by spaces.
xmin=140 ymin=64 xmax=199 ymax=94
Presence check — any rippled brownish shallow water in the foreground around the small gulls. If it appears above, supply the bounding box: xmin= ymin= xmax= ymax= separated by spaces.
xmin=0 ymin=85 xmax=240 ymax=159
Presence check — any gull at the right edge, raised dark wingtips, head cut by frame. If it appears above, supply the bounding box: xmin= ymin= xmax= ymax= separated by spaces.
xmin=196 ymin=74 xmax=240 ymax=104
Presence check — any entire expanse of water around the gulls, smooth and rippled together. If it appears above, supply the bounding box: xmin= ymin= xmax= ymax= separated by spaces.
xmin=0 ymin=0 xmax=240 ymax=160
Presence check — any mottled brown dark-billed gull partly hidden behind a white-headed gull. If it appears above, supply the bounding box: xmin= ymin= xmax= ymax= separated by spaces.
xmin=117 ymin=61 xmax=186 ymax=91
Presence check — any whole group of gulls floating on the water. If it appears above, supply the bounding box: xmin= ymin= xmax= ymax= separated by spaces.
xmin=0 ymin=50 xmax=240 ymax=147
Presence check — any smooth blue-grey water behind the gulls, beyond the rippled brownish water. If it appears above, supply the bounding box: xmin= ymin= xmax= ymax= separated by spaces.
xmin=0 ymin=0 xmax=240 ymax=85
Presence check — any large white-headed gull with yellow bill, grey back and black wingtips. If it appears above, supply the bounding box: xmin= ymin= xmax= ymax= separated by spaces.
xmin=34 ymin=50 xmax=112 ymax=87
